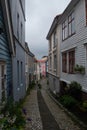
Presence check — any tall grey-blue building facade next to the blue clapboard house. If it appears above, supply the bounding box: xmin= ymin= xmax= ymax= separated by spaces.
xmin=10 ymin=0 xmax=26 ymax=101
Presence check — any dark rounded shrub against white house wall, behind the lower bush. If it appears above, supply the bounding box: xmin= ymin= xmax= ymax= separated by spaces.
xmin=68 ymin=81 xmax=82 ymax=100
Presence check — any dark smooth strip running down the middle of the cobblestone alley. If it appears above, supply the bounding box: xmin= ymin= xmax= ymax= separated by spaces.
xmin=37 ymin=90 xmax=60 ymax=130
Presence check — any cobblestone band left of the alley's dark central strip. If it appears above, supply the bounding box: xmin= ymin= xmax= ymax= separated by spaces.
xmin=24 ymin=90 xmax=43 ymax=130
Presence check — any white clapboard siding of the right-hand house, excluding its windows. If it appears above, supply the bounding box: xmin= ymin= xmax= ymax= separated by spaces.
xmin=61 ymin=0 xmax=87 ymax=92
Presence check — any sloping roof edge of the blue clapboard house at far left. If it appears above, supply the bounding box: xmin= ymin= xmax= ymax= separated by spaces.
xmin=1 ymin=0 xmax=15 ymax=56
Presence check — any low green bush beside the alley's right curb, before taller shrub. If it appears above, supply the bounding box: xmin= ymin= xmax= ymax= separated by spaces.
xmin=60 ymin=95 xmax=77 ymax=108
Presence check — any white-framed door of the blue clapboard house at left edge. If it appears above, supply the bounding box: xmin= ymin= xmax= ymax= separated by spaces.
xmin=0 ymin=63 xmax=6 ymax=102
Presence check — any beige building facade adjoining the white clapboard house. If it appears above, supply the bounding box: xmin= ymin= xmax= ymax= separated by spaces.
xmin=46 ymin=15 xmax=60 ymax=94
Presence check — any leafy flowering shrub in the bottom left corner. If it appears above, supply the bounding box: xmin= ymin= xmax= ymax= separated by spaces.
xmin=0 ymin=100 xmax=26 ymax=130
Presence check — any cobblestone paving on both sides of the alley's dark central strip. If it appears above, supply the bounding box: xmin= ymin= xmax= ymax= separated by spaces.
xmin=24 ymin=79 xmax=82 ymax=130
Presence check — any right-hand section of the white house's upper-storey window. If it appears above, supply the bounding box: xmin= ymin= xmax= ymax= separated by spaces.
xmin=68 ymin=12 xmax=75 ymax=36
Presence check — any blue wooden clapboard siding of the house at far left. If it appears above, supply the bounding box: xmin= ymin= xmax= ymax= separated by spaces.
xmin=0 ymin=6 xmax=12 ymax=96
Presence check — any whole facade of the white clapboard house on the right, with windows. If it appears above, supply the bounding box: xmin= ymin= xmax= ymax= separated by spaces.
xmin=60 ymin=0 xmax=87 ymax=96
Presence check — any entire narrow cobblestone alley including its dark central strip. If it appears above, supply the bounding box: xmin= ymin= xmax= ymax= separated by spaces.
xmin=24 ymin=79 xmax=82 ymax=130
